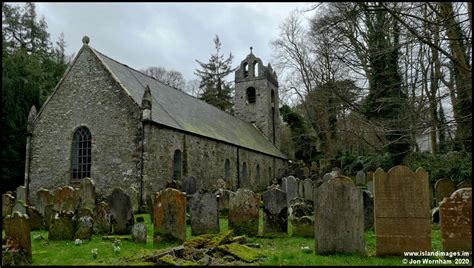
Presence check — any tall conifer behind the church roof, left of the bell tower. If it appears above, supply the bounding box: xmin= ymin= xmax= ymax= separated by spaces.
xmin=194 ymin=34 xmax=236 ymax=112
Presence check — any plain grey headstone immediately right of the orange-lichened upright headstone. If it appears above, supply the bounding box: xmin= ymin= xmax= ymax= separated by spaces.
xmin=189 ymin=192 xmax=219 ymax=235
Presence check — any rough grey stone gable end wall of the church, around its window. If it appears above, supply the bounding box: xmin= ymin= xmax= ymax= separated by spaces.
xmin=30 ymin=47 xmax=141 ymax=202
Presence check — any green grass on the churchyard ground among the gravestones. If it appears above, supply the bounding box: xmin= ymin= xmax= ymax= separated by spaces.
xmin=2 ymin=211 xmax=472 ymax=266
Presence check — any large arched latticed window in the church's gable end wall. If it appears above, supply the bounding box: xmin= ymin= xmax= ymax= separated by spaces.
xmin=71 ymin=127 xmax=92 ymax=179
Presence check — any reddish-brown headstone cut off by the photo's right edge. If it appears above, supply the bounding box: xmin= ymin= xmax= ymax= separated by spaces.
xmin=439 ymin=188 xmax=472 ymax=252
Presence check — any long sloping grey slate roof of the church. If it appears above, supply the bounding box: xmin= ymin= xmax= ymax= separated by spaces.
xmin=90 ymin=47 xmax=286 ymax=159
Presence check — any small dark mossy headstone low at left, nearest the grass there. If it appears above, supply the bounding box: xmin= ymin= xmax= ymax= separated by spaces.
xmin=48 ymin=211 xmax=76 ymax=240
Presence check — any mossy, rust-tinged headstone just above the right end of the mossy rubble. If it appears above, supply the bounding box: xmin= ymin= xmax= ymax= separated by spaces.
xmin=228 ymin=188 xmax=260 ymax=236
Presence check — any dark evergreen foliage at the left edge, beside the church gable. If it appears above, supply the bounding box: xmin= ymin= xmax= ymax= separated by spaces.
xmin=1 ymin=3 xmax=68 ymax=190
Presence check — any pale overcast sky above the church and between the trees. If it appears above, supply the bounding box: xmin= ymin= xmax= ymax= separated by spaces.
xmin=27 ymin=3 xmax=309 ymax=80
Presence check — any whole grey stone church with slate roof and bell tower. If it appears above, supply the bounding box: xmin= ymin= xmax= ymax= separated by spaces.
xmin=25 ymin=37 xmax=287 ymax=203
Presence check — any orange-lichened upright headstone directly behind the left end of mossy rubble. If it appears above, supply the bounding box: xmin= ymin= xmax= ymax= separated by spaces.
xmin=153 ymin=188 xmax=186 ymax=243
